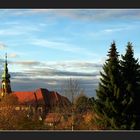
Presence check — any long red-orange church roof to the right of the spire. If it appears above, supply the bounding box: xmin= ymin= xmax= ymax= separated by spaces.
xmin=12 ymin=88 xmax=70 ymax=107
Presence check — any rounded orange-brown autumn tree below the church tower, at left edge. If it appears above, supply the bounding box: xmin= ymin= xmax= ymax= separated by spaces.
xmin=0 ymin=94 xmax=24 ymax=130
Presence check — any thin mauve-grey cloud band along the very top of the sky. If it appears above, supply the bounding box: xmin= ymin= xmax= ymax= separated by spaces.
xmin=0 ymin=9 xmax=140 ymax=21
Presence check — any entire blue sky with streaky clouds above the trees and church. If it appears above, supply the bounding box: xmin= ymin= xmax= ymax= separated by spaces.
xmin=0 ymin=9 xmax=140 ymax=97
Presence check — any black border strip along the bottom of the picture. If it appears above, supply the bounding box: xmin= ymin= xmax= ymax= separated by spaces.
xmin=0 ymin=131 xmax=140 ymax=140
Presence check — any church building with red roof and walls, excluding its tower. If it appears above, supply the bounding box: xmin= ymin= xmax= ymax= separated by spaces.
xmin=12 ymin=88 xmax=71 ymax=113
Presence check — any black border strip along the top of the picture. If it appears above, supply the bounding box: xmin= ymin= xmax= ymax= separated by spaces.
xmin=0 ymin=0 xmax=140 ymax=8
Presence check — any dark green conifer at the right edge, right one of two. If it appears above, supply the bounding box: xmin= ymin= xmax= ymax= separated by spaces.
xmin=120 ymin=42 xmax=140 ymax=129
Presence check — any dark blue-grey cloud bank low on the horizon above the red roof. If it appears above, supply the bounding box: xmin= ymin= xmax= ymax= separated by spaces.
xmin=6 ymin=67 xmax=99 ymax=97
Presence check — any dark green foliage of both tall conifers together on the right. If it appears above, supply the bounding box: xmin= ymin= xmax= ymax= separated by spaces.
xmin=94 ymin=42 xmax=140 ymax=130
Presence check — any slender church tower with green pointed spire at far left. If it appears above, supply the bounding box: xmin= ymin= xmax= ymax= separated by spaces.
xmin=1 ymin=54 xmax=12 ymax=97
